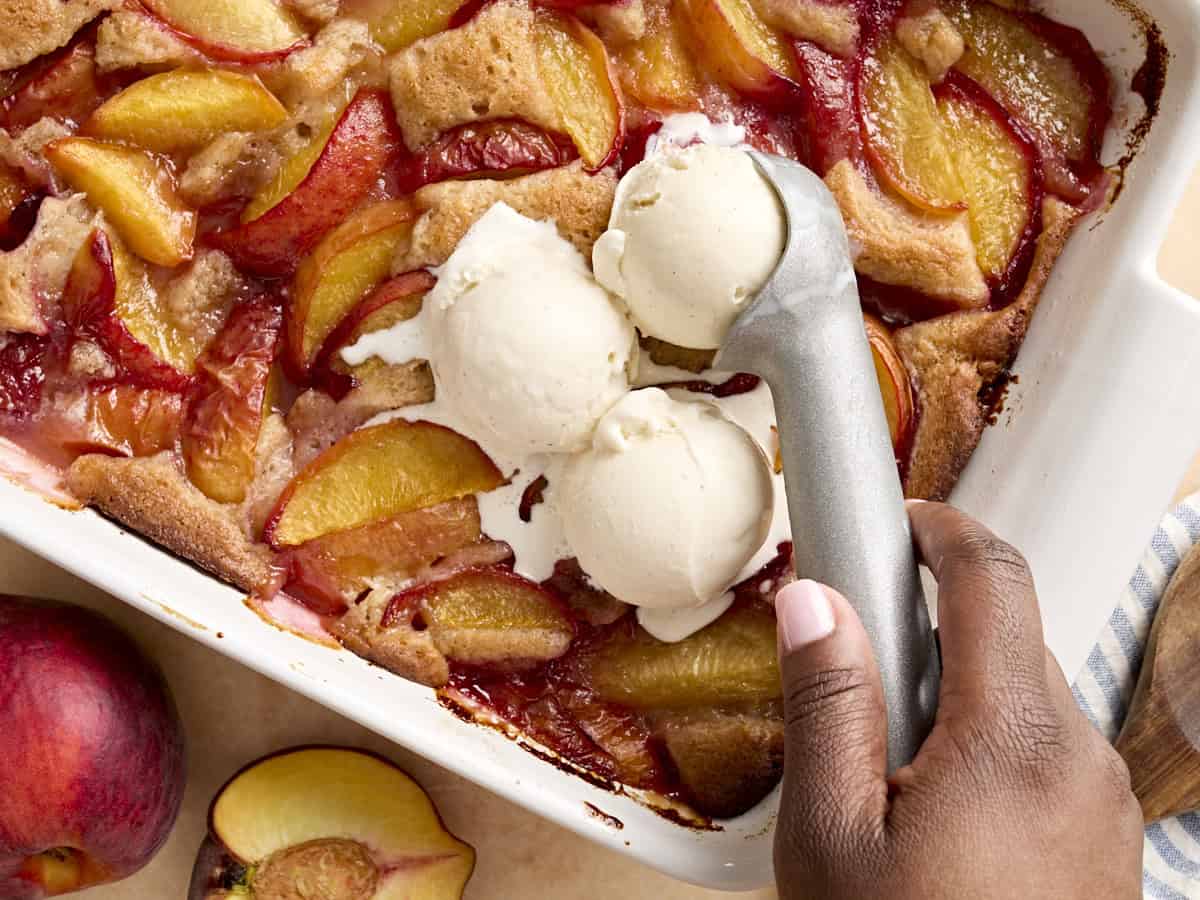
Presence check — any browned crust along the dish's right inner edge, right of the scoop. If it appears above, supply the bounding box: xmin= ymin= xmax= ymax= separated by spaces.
xmin=895 ymin=198 xmax=1080 ymax=500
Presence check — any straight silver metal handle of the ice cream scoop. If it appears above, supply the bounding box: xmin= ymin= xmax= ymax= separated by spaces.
xmin=768 ymin=305 xmax=940 ymax=772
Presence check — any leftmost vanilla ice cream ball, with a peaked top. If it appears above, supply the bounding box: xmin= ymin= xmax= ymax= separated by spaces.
xmin=426 ymin=203 xmax=637 ymax=457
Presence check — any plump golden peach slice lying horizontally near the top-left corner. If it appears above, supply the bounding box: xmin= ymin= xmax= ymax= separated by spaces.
xmin=84 ymin=70 xmax=288 ymax=154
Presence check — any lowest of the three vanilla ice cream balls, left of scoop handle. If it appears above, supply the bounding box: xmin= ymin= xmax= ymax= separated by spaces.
xmin=551 ymin=388 xmax=773 ymax=610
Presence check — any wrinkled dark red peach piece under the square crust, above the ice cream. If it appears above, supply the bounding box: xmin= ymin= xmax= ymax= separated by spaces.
xmin=396 ymin=119 xmax=578 ymax=193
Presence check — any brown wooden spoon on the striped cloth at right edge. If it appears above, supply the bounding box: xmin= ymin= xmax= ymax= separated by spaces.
xmin=1116 ymin=546 xmax=1200 ymax=823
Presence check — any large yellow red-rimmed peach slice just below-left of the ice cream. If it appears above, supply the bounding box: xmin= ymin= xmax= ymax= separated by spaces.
xmin=264 ymin=419 xmax=504 ymax=547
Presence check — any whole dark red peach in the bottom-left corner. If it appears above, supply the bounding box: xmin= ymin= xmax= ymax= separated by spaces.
xmin=0 ymin=595 xmax=185 ymax=900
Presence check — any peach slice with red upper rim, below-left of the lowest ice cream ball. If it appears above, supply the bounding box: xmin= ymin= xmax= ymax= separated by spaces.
xmin=384 ymin=566 xmax=575 ymax=667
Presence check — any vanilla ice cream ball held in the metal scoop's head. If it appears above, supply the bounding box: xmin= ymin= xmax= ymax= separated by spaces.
xmin=592 ymin=144 xmax=787 ymax=349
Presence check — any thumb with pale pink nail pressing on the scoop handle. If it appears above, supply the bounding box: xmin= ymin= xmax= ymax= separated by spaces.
xmin=775 ymin=581 xmax=888 ymax=871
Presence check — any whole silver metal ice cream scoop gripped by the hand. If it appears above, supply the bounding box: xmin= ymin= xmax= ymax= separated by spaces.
xmin=715 ymin=152 xmax=940 ymax=772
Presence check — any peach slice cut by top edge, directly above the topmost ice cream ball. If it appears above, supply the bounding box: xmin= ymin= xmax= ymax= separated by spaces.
xmin=682 ymin=0 xmax=796 ymax=101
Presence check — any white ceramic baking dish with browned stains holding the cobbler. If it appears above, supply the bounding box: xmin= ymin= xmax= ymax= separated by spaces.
xmin=0 ymin=0 xmax=1200 ymax=889
